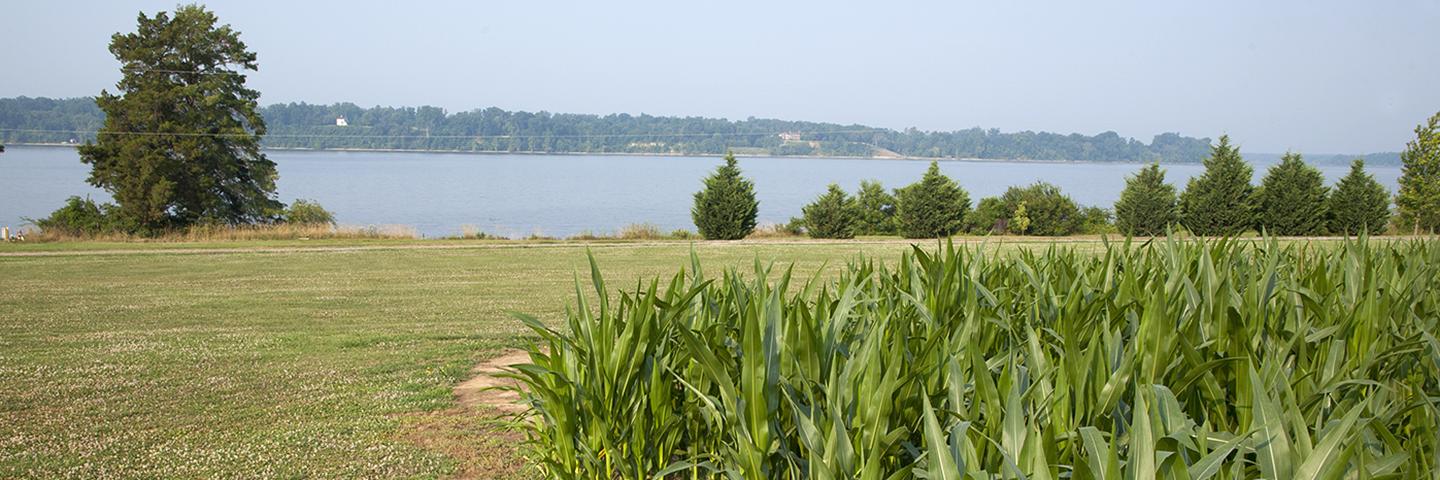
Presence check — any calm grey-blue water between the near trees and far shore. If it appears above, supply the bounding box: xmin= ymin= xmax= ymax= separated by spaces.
xmin=0 ymin=147 xmax=1400 ymax=236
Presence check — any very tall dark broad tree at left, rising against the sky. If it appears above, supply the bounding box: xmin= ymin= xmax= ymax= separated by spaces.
xmin=79 ymin=4 xmax=282 ymax=234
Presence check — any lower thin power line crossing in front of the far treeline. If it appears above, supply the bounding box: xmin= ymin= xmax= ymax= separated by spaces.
xmin=0 ymin=128 xmax=886 ymax=140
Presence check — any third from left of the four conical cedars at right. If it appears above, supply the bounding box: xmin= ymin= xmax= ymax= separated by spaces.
xmin=1256 ymin=153 xmax=1329 ymax=236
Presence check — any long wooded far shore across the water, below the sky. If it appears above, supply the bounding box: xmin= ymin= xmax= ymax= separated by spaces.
xmin=0 ymin=95 xmax=1210 ymax=163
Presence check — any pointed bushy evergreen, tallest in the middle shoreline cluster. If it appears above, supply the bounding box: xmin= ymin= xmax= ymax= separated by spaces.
xmin=896 ymin=161 xmax=971 ymax=238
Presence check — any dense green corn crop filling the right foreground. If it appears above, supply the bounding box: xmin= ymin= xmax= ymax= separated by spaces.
xmin=513 ymin=239 xmax=1440 ymax=480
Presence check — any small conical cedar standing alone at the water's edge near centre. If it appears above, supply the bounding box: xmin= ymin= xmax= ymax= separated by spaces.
xmin=690 ymin=151 xmax=760 ymax=239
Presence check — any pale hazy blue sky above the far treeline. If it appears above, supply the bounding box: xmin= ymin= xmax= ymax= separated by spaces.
xmin=0 ymin=0 xmax=1440 ymax=153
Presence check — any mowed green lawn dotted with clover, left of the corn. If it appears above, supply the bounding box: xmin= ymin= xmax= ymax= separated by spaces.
xmin=0 ymin=242 xmax=950 ymax=479
